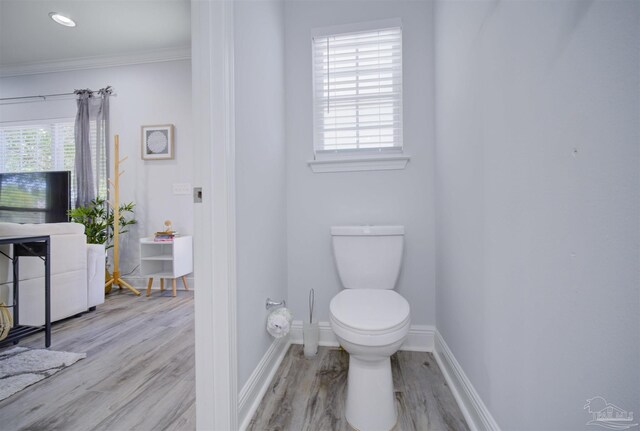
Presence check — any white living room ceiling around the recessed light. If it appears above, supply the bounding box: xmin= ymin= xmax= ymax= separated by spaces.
xmin=0 ymin=0 xmax=191 ymax=68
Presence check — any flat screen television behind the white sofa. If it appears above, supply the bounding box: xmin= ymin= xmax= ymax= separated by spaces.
xmin=0 ymin=171 xmax=71 ymax=223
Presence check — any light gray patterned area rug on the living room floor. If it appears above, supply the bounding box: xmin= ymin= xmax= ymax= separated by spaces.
xmin=0 ymin=347 xmax=87 ymax=401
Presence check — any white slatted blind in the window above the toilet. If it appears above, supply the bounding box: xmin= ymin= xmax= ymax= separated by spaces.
xmin=313 ymin=22 xmax=402 ymax=155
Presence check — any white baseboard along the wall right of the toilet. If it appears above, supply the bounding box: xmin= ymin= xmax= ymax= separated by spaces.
xmin=434 ymin=330 xmax=500 ymax=431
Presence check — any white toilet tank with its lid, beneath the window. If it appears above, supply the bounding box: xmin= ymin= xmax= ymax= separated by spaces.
xmin=331 ymin=226 xmax=404 ymax=289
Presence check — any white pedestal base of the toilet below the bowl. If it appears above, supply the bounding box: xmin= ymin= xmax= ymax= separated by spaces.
xmin=345 ymin=355 xmax=398 ymax=431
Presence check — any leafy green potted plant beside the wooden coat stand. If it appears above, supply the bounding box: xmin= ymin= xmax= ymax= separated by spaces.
xmin=69 ymin=197 xmax=137 ymax=293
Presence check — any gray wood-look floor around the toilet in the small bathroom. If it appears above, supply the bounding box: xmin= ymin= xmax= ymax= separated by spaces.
xmin=248 ymin=345 xmax=469 ymax=431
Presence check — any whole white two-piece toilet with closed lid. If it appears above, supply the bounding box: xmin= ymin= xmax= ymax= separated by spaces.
xmin=329 ymin=226 xmax=410 ymax=431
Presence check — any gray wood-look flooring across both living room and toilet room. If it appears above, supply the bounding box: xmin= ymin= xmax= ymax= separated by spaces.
xmin=0 ymin=291 xmax=468 ymax=431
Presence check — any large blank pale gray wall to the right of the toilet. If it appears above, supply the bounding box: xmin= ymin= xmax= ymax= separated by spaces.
xmin=436 ymin=1 xmax=640 ymax=430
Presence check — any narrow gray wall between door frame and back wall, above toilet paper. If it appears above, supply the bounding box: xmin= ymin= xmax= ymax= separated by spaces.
xmin=234 ymin=1 xmax=287 ymax=389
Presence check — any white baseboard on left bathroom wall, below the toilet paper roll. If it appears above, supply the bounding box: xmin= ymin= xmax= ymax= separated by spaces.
xmin=238 ymin=337 xmax=291 ymax=431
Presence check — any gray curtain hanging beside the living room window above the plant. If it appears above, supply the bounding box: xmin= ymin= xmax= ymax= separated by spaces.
xmin=75 ymin=87 xmax=111 ymax=206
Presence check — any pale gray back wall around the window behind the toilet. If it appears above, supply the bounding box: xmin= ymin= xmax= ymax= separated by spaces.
xmin=285 ymin=1 xmax=435 ymax=324
